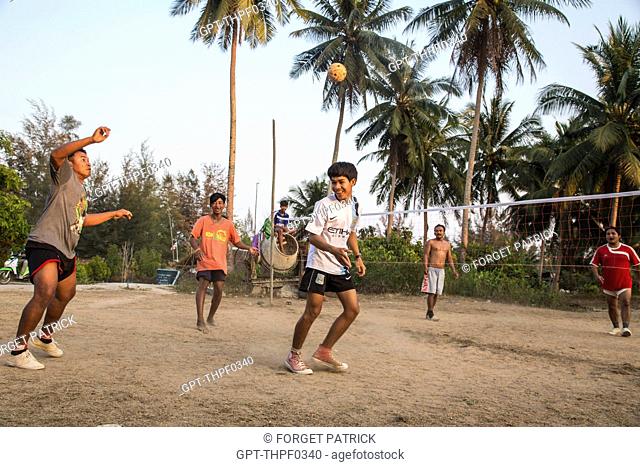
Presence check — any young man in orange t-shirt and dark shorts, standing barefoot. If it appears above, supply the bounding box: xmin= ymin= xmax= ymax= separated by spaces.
xmin=189 ymin=193 xmax=258 ymax=334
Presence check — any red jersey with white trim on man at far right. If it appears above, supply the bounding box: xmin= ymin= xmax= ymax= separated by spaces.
xmin=591 ymin=243 xmax=640 ymax=291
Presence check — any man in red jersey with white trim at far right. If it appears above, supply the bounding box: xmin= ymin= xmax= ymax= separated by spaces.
xmin=591 ymin=226 xmax=640 ymax=337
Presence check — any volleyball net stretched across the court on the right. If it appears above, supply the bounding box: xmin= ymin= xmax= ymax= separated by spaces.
xmin=350 ymin=190 xmax=640 ymax=291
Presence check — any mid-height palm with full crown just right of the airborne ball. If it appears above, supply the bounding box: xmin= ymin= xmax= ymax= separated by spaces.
xmin=347 ymin=54 xmax=460 ymax=237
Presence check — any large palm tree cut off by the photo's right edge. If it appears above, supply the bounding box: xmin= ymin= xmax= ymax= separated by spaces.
xmin=539 ymin=18 xmax=640 ymax=225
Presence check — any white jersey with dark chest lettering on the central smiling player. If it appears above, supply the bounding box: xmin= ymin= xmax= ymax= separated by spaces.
xmin=306 ymin=193 xmax=358 ymax=275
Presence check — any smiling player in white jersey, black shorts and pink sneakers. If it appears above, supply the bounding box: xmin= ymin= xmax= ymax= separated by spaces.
xmin=285 ymin=162 xmax=366 ymax=375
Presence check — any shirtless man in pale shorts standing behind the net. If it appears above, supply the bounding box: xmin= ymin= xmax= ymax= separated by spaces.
xmin=424 ymin=224 xmax=460 ymax=321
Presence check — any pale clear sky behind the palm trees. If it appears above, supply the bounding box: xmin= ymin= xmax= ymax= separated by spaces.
xmin=0 ymin=0 xmax=640 ymax=239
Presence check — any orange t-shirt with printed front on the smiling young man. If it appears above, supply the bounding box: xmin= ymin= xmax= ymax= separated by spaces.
xmin=191 ymin=216 xmax=240 ymax=274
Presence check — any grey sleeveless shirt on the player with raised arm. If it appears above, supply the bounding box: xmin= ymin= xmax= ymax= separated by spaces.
xmin=28 ymin=159 xmax=88 ymax=259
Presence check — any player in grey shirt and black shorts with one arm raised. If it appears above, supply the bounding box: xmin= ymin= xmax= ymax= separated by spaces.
xmin=8 ymin=126 xmax=132 ymax=370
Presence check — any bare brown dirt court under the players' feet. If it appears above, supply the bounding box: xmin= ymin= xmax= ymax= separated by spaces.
xmin=0 ymin=284 xmax=640 ymax=426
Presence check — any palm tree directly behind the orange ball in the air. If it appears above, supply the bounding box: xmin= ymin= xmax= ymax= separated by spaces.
xmin=290 ymin=0 xmax=411 ymax=170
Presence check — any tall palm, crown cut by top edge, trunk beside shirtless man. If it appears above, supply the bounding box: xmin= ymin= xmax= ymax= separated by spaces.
xmin=406 ymin=0 xmax=591 ymax=259
